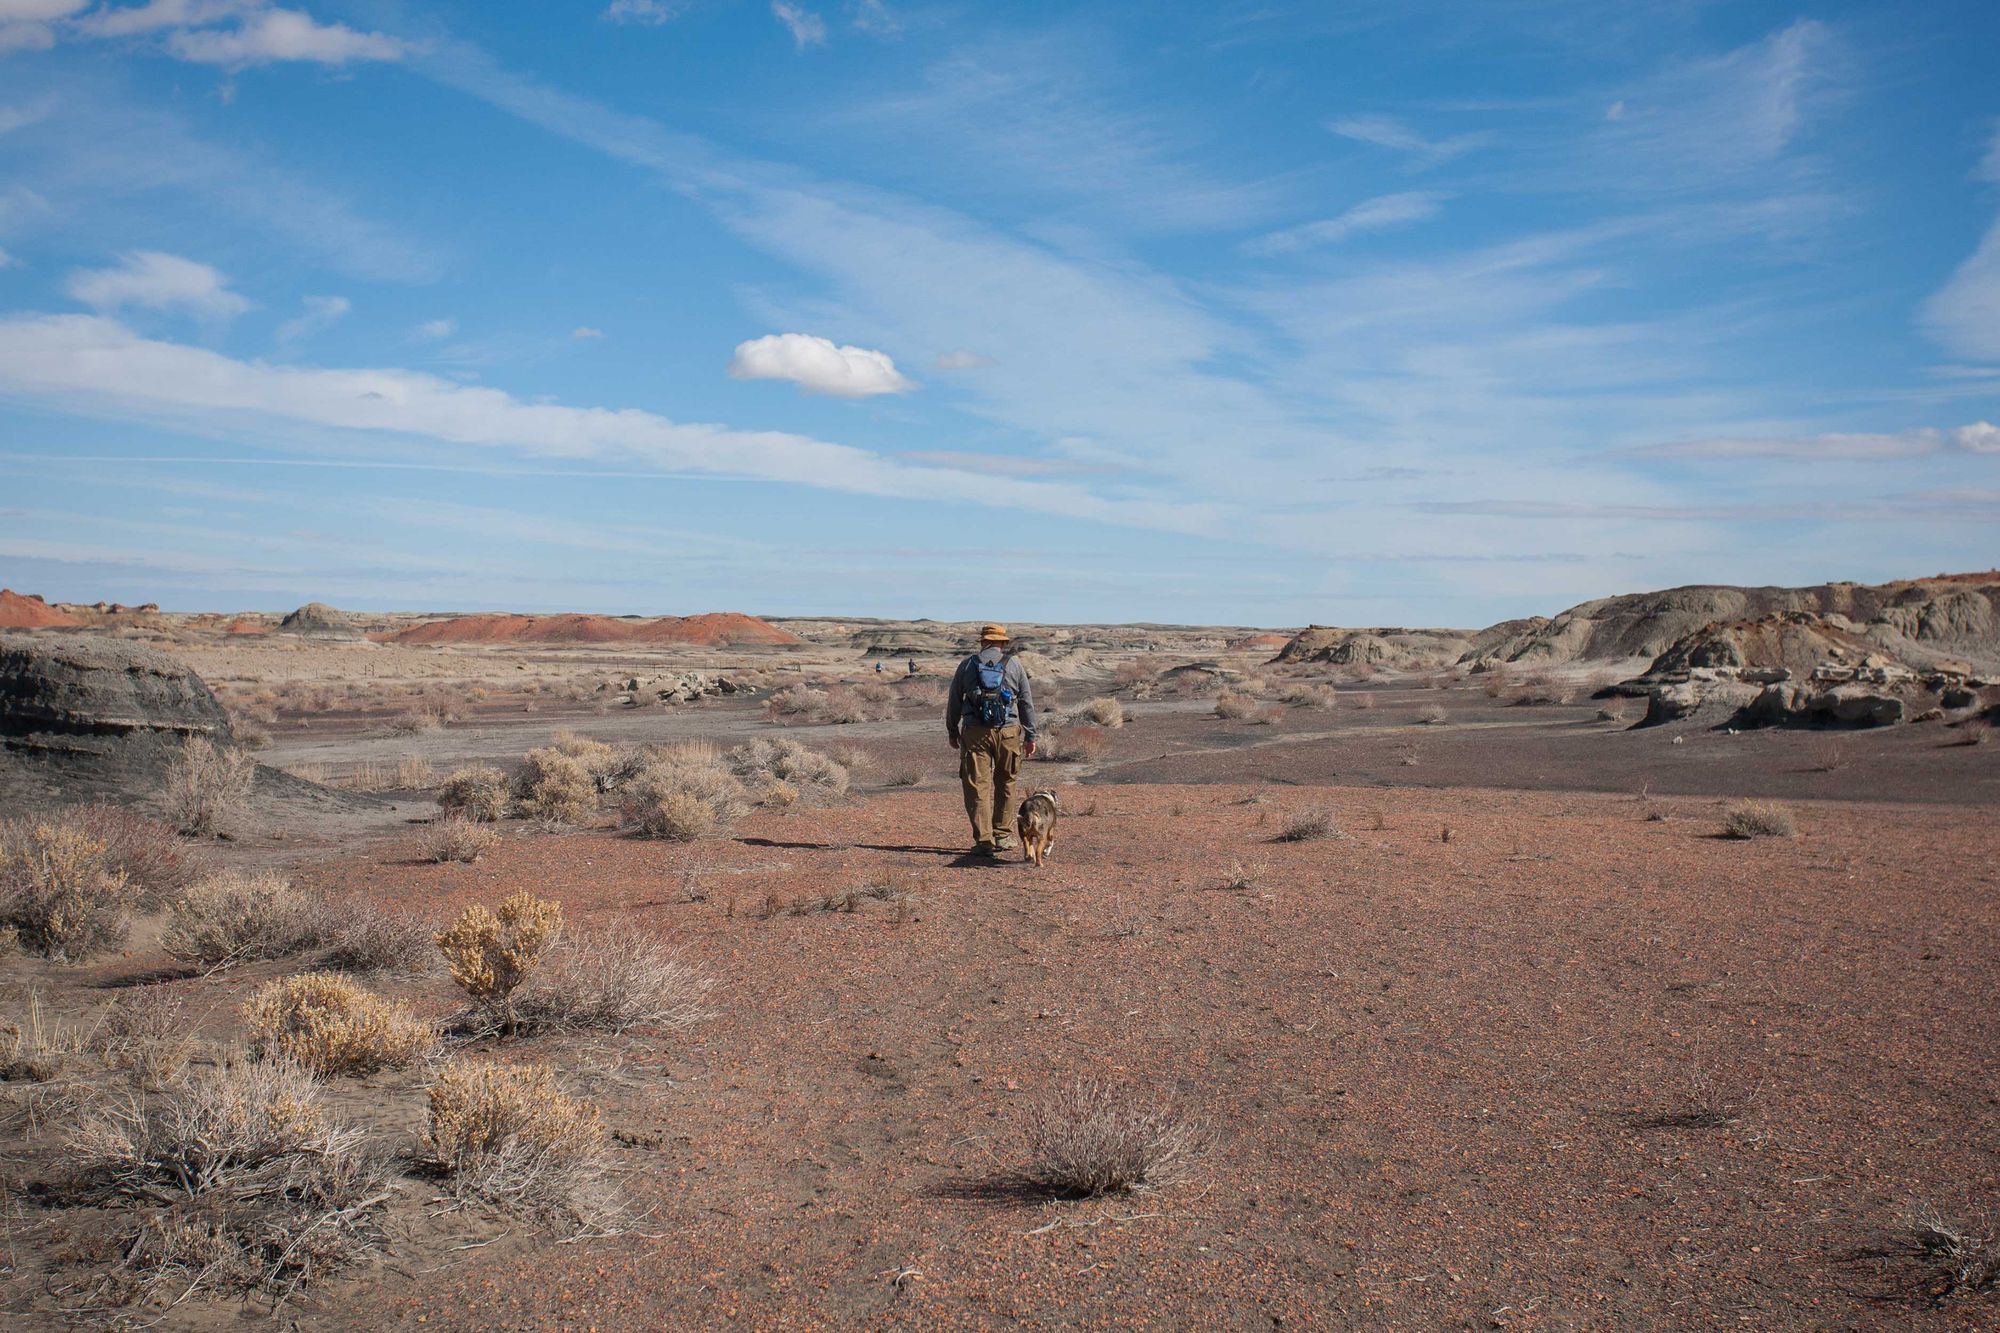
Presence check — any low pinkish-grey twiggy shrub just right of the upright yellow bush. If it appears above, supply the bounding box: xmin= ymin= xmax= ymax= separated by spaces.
xmin=518 ymin=929 xmax=712 ymax=1033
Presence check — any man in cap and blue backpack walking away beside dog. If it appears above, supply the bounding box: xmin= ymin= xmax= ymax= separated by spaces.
xmin=944 ymin=624 xmax=1034 ymax=857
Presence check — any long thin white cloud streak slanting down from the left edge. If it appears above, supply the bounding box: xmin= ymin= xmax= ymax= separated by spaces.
xmin=0 ymin=314 xmax=1220 ymax=532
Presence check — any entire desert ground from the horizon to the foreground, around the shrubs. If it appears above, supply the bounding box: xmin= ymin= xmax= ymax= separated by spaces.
xmin=0 ymin=588 xmax=2000 ymax=1329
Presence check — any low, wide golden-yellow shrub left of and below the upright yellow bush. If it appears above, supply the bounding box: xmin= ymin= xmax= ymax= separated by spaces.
xmin=244 ymin=973 xmax=438 ymax=1075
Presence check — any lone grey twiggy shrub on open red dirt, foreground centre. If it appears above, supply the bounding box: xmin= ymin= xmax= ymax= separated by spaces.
xmin=1026 ymin=1079 xmax=1214 ymax=1197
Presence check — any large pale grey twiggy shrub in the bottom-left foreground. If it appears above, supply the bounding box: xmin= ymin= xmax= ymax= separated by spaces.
xmin=68 ymin=1061 xmax=388 ymax=1305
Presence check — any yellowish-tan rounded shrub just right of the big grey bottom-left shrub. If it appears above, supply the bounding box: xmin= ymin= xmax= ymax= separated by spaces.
xmin=424 ymin=1061 xmax=606 ymax=1215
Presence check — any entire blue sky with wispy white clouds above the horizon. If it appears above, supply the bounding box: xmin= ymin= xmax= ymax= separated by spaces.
xmin=0 ymin=0 xmax=2000 ymax=624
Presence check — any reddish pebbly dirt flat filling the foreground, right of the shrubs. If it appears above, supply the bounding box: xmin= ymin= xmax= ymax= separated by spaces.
xmin=292 ymin=787 xmax=2000 ymax=1331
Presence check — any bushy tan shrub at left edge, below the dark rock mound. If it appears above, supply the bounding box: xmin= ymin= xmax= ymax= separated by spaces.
xmin=0 ymin=821 xmax=136 ymax=963
